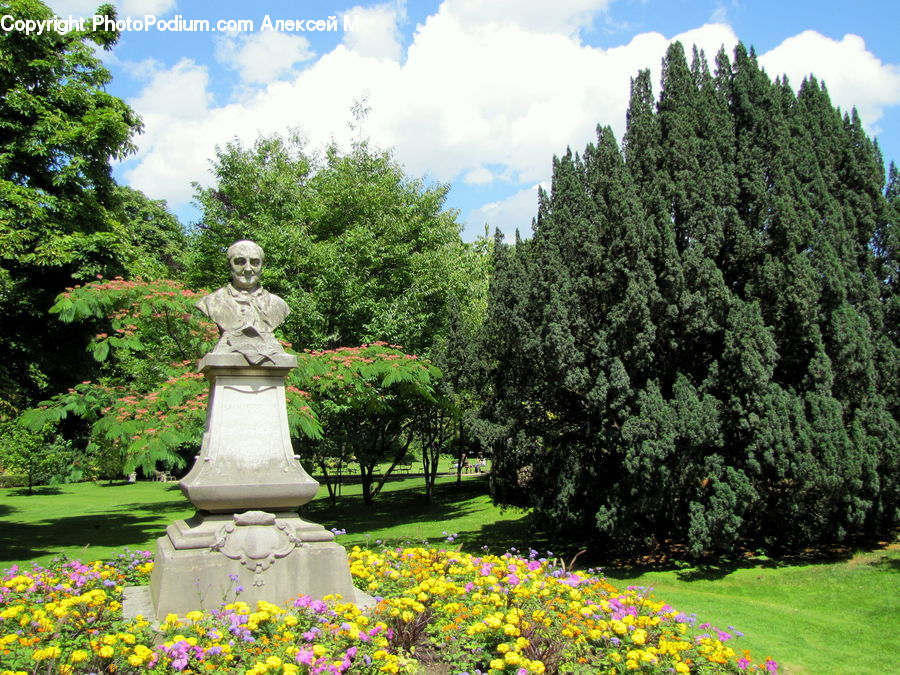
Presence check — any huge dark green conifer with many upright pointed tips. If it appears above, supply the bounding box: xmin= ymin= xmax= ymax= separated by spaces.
xmin=479 ymin=43 xmax=900 ymax=555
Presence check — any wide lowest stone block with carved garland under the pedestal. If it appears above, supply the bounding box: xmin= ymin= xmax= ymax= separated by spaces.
xmin=150 ymin=511 xmax=362 ymax=619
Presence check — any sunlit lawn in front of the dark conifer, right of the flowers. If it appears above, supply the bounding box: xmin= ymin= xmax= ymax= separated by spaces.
xmin=606 ymin=546 xmax=900 ymax=675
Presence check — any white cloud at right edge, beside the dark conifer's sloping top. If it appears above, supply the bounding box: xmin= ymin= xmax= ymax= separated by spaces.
xmin=759 ymin=30 xmax=900 ymax=132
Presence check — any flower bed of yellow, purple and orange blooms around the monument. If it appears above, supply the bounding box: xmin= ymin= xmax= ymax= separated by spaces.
xmin=0 ymin=547 xmax=777 ymax=675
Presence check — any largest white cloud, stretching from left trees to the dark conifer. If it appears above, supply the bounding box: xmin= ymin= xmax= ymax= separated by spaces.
xmin=118 ymin=7 xmax=736 ymax=224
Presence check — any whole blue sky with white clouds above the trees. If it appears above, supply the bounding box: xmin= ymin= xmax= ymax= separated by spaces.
xmin=49 ymin=0 xmax=900 ymax=239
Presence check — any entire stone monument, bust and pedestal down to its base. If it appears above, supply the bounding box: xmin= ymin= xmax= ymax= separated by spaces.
xmin=150 ymin=241 xmax=371 ymax=619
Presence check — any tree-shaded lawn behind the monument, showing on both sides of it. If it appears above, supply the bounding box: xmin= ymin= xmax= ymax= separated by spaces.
xmin=0 ymin=475 xmax=528 ymax=568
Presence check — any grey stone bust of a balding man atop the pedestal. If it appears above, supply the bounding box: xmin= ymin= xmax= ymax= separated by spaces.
xmin=196 ymin=240 xmax=290 ymax=366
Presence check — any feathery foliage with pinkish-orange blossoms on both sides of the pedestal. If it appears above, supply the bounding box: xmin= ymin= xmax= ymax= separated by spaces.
xmin=22 ymin=278 xmax=440 ymax=480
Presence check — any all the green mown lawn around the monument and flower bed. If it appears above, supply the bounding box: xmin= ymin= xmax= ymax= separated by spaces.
xmin=0 ymin=476 xmax=900 ymax=674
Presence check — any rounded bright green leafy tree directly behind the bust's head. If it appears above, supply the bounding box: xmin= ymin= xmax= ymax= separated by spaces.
xmin=188 ymin=134 xmax=484 ymax=354
